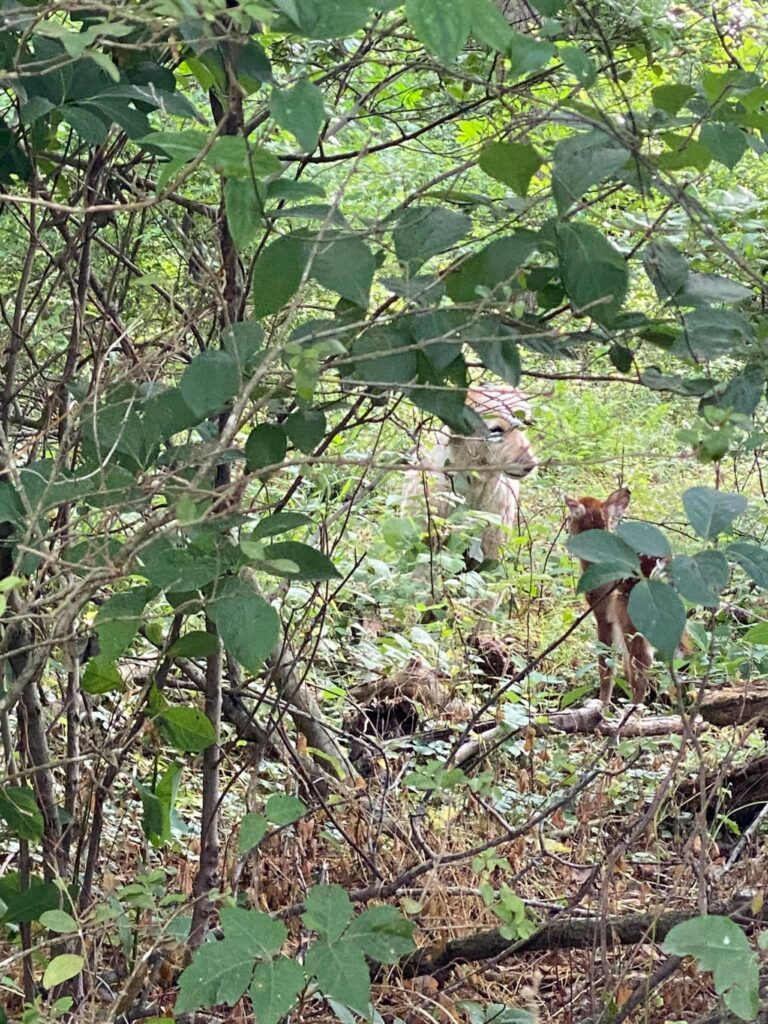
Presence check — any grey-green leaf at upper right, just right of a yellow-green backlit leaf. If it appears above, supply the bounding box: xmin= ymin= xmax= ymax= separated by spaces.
xmin=552 ymin=129 xmax=629 ymax=213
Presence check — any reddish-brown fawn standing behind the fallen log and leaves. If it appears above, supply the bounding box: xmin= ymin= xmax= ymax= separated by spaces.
xmin=565 ymin=487 xmax=666 ymax=703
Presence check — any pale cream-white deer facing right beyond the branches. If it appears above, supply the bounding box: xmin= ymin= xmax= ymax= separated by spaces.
xmin=402 ymin=384 xmax=539 ymax=562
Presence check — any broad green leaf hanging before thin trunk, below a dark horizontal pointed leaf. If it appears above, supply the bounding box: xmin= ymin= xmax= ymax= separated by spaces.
xmin=206 ymin=579 xmax=280 ymax=673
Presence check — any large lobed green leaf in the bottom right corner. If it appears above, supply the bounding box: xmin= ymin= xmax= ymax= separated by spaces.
xmin=662 ymin=915 xmax=760 ymax=1020
